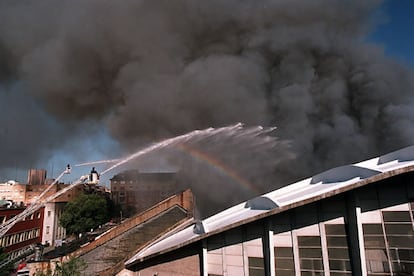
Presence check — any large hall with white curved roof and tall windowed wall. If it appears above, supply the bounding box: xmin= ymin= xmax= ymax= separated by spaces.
xmin=125 ymin=146 xmax=414 ymax=276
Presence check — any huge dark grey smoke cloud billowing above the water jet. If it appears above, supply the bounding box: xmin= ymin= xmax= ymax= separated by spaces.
xmin=0 ymin=0 xmax=414 ymax=198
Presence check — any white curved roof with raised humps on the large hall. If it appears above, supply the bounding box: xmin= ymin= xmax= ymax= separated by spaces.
xmin=126 ymin=146 xmax=414 ymax=266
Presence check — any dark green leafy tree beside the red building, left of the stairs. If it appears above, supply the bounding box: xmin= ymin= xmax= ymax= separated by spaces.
xmin=59 ymin=194 xmax=109 ymax=234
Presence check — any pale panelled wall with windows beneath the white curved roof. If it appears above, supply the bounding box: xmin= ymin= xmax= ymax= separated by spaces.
xmin=207 ymin=183 xmax=414 ymax=276
